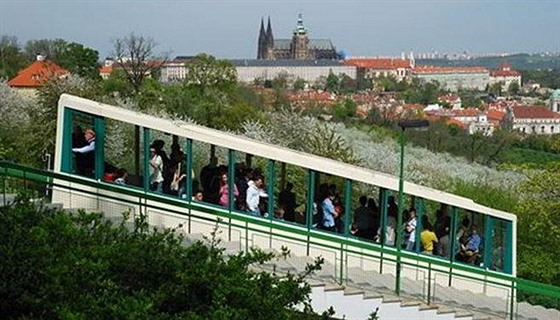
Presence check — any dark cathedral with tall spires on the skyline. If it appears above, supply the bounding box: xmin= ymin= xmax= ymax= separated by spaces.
xmin=257 ymin=14 xmax=339 ymax=60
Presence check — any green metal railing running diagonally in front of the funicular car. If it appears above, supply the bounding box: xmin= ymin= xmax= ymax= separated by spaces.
xmin=0 ymin=162 xmax=560 ymax=319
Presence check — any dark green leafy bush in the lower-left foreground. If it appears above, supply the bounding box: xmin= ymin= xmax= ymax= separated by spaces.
xmin=0 ymin=202 xmax=328 ymax=319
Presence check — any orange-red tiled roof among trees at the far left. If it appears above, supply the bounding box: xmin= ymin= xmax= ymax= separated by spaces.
xmin=8 ymin=60 xmax=69 ymax=88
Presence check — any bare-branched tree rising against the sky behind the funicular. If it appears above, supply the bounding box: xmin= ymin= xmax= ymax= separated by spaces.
xmin=113 ymin=33 xmax=167 ymax=93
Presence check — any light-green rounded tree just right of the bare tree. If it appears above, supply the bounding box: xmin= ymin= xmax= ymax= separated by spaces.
xmin=185 ymin=53 xmax=237 ymax=95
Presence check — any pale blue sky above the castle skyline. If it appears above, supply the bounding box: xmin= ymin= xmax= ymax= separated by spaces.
xmin=0 ymin=0 xmax=560 ymax=58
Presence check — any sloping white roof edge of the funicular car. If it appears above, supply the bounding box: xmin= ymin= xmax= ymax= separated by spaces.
xmin=59 ymin=94 xmax=517 ymax=221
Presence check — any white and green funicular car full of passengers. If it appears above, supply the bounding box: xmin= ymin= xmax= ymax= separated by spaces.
xmin=53 ymin=95 xmax=516 ymax=311
